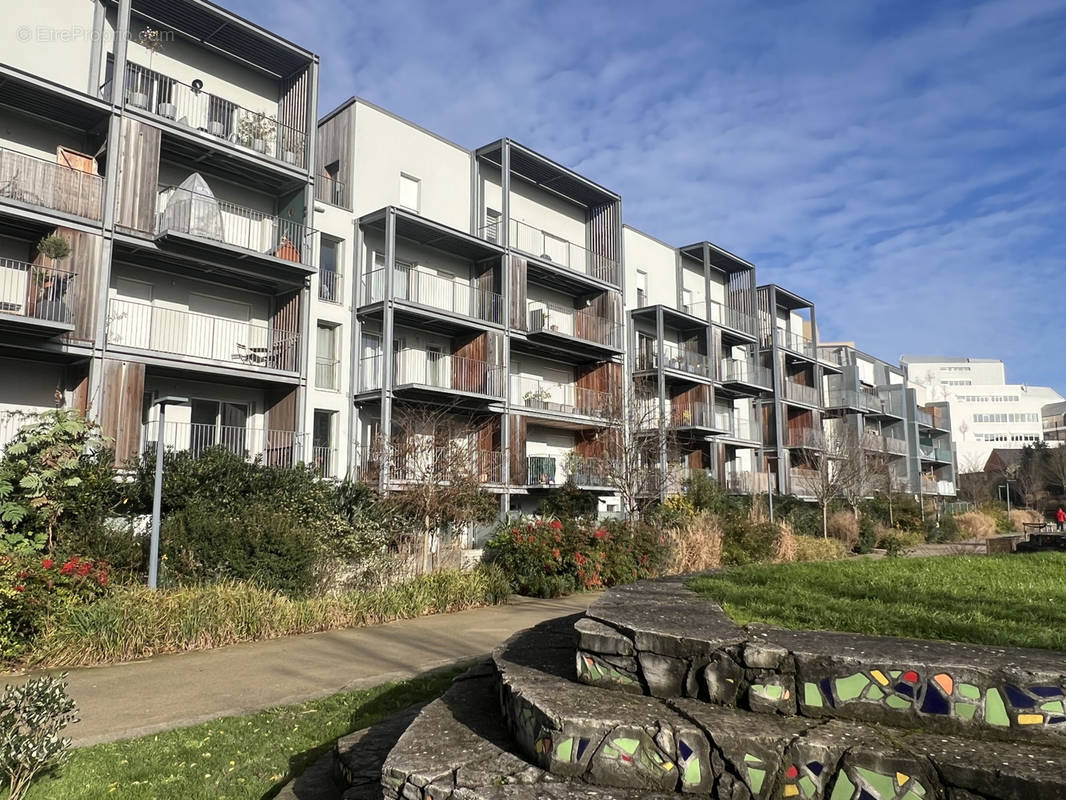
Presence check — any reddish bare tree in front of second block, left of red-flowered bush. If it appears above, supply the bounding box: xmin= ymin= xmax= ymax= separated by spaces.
xmin=372 ymin=403 xmax=502 ymax=572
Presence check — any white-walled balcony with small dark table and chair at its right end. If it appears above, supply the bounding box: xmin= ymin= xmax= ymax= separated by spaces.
xmin=108 ymin=298 xmax=300 ymax=372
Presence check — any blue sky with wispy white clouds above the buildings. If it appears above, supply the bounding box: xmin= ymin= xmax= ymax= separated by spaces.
xmin=235 ymin=0 xmax=1066 ymax=395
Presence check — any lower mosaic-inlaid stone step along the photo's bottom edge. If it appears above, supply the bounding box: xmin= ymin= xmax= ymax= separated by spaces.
xmin=494 ymin=619 xmax=1066 ymax=800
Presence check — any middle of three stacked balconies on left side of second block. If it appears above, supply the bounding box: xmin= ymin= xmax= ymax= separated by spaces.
xmin=359 ymin=350 xmax=504 ymax=399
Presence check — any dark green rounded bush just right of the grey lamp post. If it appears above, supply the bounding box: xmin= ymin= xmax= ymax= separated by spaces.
xmin=160 ymin=501 xmax=321 ymax=596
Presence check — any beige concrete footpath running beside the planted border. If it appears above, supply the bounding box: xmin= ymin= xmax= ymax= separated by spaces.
xmin=0 ymin=594 xmax=597 ymax=746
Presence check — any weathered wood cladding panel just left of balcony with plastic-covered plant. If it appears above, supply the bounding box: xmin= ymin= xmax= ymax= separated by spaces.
xmin=115 ymin=117 xmax=162 ymax=234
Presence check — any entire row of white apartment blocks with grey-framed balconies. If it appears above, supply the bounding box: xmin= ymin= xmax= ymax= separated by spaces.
xmin=0 ymin=0 xmax=954 ymax=513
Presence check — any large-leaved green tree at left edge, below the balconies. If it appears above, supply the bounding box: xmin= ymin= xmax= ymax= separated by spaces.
xmin=0 ymin=410 xmax=106 ymax=553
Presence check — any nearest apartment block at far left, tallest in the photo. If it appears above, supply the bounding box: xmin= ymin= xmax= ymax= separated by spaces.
xmin=0 ymin=0 xmax=318 ymax=464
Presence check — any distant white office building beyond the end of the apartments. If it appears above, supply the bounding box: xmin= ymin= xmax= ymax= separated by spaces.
xmin=900 ymin=355 xmax=1063 ymax=473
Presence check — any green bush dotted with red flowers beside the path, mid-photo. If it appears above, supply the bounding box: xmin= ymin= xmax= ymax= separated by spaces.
xmin=485 ymin=519 xmax=669 ymax=597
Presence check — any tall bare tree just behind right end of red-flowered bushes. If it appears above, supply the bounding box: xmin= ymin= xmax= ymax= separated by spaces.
xmin=597 ymin=382 xmax=677 ymax=519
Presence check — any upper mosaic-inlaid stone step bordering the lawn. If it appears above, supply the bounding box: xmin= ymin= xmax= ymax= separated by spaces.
xmin=576 ymin=579 xmax=1066 ymax=747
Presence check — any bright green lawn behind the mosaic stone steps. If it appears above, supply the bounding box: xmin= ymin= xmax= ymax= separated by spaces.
xmin=688 ymin=554 xmax=1066 ymax=651
